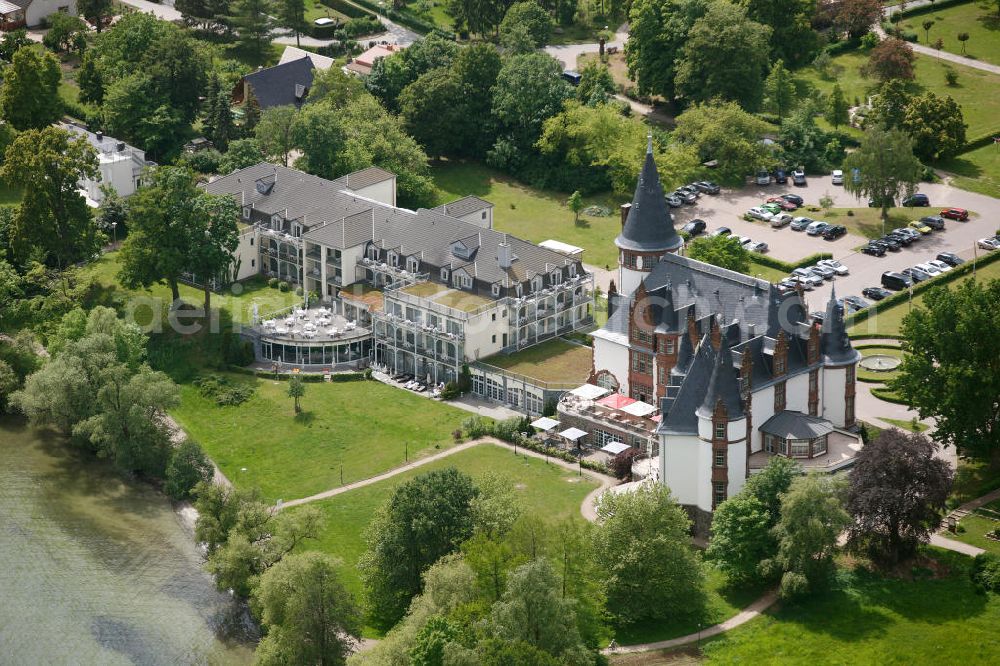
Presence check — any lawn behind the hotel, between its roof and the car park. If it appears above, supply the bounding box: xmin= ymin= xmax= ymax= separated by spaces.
xmin=431 ymin=162 xmax=624 ymax=266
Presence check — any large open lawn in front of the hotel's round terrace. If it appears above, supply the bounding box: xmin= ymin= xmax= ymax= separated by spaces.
xmin=172 ymin=375 xmax=466 ymax=501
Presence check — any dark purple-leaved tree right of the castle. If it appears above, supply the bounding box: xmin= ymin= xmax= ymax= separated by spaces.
xmin=847 ymin=428 xmax=952 ymax=565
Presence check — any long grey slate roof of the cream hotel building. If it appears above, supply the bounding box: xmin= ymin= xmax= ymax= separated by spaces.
xmin=205 ymin=162 xmax=576 ymax=283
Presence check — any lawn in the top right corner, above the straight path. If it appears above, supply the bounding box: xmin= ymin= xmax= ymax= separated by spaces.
xmin=901 ymin=2 xmax=1000 ymax=65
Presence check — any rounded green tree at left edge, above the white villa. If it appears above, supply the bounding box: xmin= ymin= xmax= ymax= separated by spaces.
xmin=0 ymin=48 xmax=62 ymax=130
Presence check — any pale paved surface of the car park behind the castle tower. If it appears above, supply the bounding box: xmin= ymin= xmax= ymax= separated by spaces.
xmin=671 ymin=175 xmax=1000 ymax=310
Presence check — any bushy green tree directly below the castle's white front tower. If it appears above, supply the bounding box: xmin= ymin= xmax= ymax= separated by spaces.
xmin=593 ymin=484 xmax=705 ymax=623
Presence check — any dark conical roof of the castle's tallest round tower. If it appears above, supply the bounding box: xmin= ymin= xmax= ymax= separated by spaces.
xmin=615 ymin=136 xmax=684 ymax=252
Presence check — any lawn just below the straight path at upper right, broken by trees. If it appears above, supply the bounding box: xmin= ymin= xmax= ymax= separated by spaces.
xmin=795 ymin=50 xmax=1000 ymax=140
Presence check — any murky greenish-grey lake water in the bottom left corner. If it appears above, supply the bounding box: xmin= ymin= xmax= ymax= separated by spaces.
xmin=0 ymin=418 xmax=253 ymax=666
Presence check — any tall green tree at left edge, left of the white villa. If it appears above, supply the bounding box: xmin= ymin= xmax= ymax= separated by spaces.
xmin=0 ymin=127 xmax=101 ymax=268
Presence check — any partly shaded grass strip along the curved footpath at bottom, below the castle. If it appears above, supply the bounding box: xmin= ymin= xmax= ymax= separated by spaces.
xmin=615 ymin=566 xmax=764 ymax=645
